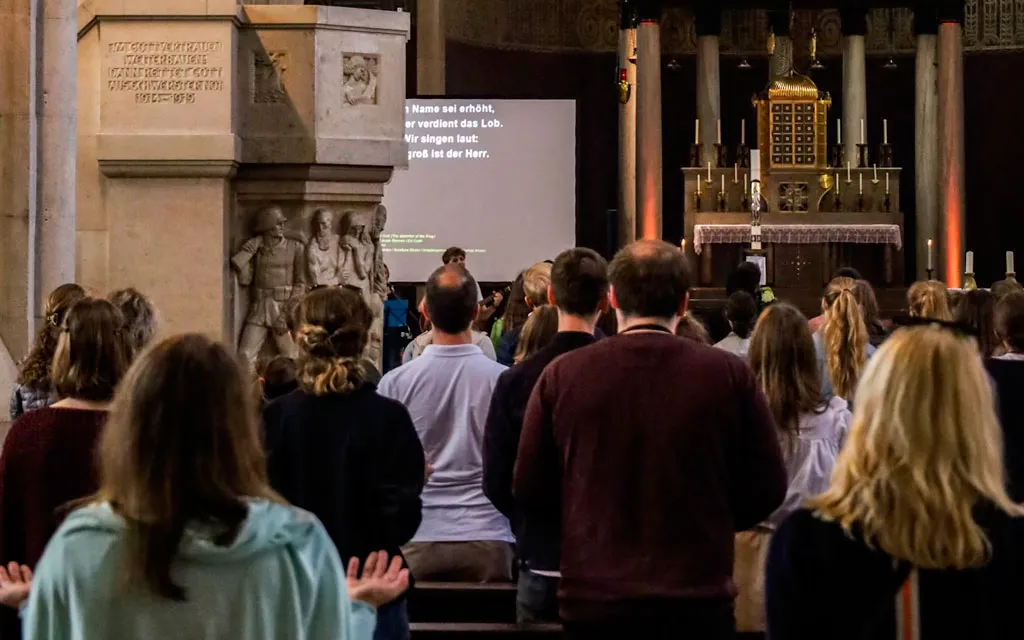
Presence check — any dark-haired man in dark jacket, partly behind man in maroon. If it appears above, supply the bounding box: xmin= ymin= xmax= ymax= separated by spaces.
xmin=483 ymin=249 xmax=608 ymax=624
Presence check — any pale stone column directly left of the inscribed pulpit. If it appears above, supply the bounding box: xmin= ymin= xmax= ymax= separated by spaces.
xmin=34 ymin=0 xmax=78 ymax=323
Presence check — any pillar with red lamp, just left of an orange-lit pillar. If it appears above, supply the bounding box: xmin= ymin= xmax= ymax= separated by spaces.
xmin=618 ymin=0 xmax=637 ymax=248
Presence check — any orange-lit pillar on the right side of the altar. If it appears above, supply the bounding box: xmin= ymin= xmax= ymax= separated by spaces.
xmin=938 ymin=5 xmax=967 ymax=288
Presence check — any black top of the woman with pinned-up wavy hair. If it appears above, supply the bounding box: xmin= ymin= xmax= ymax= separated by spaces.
xmin=263 ymin=385 xmax=424 ymax=563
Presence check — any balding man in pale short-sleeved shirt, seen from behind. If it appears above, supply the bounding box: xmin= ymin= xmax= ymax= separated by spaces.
xmin=378 ymin=265 xmax=515 ymax=583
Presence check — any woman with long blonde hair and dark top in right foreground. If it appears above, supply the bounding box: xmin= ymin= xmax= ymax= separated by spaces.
xmin=767 ymin=326 xmax=1024 ymax=640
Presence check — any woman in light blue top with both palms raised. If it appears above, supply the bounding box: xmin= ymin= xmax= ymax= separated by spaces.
xmin=0 ymin=335 xmax=409 ymax=640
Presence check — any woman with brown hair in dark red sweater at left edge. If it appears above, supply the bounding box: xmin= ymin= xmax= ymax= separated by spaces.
xmin=0 ymin=298 xmax=128 ymax=638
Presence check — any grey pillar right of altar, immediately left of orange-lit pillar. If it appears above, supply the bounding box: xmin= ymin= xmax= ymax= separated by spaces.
xmin=913 ymin=7 xmax=943 ymax=280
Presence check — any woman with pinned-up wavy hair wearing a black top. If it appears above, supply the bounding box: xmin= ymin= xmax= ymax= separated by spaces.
xmin=263 ymin=288 xmax=426 ymax=640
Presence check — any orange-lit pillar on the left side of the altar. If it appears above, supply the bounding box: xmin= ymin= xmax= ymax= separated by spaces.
xmin=637 ymin=3 xmax=662 ymax=240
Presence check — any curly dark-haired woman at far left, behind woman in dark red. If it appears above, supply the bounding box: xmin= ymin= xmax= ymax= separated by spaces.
xmin=10 ymin=284 xmax=85 ymax=420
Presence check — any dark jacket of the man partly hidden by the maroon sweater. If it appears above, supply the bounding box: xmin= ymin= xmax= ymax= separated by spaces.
xmin=483 ymin=332 xmax=595 ymax=571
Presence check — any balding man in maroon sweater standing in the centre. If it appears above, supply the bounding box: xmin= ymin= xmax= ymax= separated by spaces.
xmin=514 ymin=241 xmax=786 ymax=639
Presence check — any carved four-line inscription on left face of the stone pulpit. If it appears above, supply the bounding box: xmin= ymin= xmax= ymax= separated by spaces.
xmin=106 ymin=40 xmax=225 ymax=104
